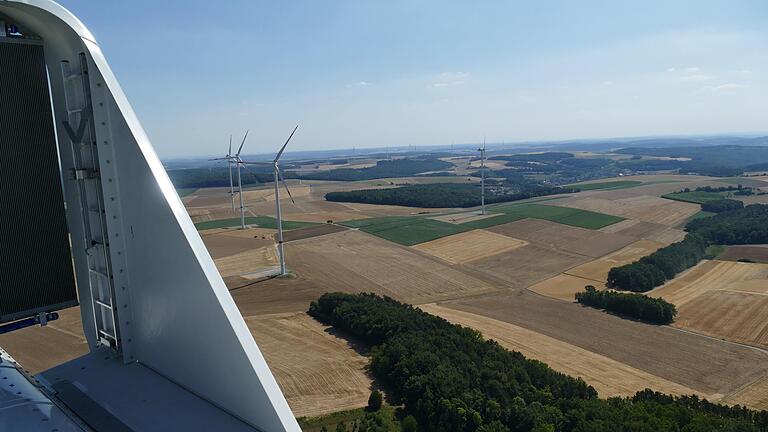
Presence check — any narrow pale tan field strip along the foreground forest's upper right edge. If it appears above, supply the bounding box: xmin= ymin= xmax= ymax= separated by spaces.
xmin=419 ymin=304 xmax=709 ymax=397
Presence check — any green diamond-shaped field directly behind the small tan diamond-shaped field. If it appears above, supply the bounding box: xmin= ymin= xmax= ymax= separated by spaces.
xmin=340 ymin=216 xmax=474 ymax=246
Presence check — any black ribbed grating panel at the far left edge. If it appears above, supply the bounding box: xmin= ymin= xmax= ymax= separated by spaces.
xmin=0 ymin=42 xmax=77 ymax=322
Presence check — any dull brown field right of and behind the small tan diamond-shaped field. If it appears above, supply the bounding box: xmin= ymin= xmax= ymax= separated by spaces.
xmin=488 ymin=219 xmax=635 ymax=258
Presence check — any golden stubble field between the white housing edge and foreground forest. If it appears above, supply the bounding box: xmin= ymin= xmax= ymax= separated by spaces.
xmin=245 ymin=313 xmax=371 ymax=417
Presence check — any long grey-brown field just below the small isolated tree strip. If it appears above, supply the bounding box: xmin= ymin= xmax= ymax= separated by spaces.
xmin=439 ymin=290 xmax=768 ymax=399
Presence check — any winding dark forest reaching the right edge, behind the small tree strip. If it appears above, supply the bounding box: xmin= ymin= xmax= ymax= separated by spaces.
xmin=608 ymin=204 xmax=768 ymax=292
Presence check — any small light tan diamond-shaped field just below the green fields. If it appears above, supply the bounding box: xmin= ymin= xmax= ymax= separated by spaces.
xmin=414 ymin=230 xmax=528 ymax=264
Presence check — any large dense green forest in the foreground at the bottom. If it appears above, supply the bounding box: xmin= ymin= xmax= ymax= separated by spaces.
xmin=309 ymin=293 xmax=768 ymax=432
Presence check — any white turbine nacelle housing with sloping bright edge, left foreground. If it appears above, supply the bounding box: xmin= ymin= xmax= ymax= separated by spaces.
xmin=0 ymin=0 xmax=300 ymax=431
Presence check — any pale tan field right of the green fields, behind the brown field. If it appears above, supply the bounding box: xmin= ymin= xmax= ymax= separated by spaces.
xmin=560 ymin=196 xmax=701 ymax=226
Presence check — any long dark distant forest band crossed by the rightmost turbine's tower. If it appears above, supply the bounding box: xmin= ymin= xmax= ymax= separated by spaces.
xmin=325 ymin=182 xmax=572 ymax=208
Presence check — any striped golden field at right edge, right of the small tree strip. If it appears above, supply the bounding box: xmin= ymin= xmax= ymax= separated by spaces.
xmin=650 ymin=260 xmax=768 ymax=348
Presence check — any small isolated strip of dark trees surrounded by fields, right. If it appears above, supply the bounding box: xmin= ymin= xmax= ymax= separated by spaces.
xmin=576 ymin=285 xmax=677 ymax=325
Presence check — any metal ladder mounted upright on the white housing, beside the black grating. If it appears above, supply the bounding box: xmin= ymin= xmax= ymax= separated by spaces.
xmin=61 ymin=53 xmax=120 ymax=352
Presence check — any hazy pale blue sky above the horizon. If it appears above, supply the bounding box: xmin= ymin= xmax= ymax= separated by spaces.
xmin=61 ymin=0 xmax=768 ymax=157
